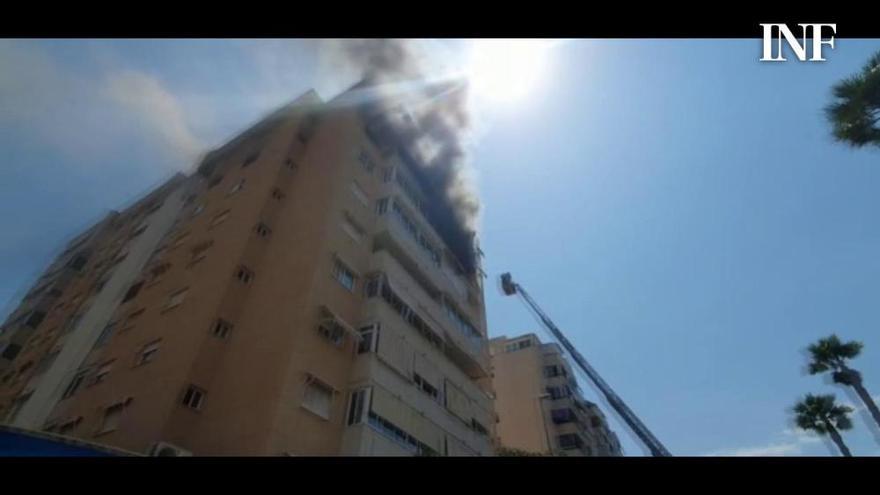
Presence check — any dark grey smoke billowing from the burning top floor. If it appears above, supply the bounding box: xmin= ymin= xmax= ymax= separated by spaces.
xmin=328 ymin=39 xmax=480 ymax=270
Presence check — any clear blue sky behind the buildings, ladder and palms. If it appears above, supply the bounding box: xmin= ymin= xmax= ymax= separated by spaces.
xmin=0 ymin=39 xmax=880 ymax=455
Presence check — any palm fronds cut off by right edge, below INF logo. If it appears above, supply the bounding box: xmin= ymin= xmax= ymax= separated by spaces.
xmin=825 ymin=52 xmax=880 ymax=148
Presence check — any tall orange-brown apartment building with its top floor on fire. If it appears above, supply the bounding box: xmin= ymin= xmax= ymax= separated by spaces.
xmin=0 ymin=84 xmax=496 ymax=455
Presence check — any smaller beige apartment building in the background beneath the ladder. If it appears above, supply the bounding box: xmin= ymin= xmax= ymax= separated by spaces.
xmin=490 ymin=334 xmax=622 ymax=456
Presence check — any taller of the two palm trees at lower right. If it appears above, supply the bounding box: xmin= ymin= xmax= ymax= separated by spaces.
xmin=808 ymin=334 xmax=880 ymax=432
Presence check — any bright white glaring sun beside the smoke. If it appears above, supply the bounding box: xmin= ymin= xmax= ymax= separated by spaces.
xmin=465 ymin=39 xmax=553 ymax=102
